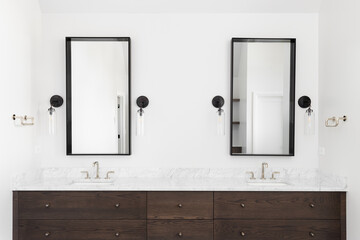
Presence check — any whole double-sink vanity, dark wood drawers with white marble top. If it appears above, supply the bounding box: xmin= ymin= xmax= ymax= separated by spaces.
xmin=13 ymin=168 xmax=346 ymax=240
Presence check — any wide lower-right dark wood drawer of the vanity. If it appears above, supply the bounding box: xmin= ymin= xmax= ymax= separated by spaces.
xmin=214 ymin=220 xmax=341 ymax=240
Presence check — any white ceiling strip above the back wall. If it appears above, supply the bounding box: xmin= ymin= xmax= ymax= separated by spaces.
xmin=39 ymin=0 xmax=322 ymax=13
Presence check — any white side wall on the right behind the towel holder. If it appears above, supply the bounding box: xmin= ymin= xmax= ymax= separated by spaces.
xmin=319 ymin=0 xmax=360 ymax=240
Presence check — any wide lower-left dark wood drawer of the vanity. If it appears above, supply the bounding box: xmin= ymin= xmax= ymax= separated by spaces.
xmin=19 ymin=220 xmax=146 ymax=240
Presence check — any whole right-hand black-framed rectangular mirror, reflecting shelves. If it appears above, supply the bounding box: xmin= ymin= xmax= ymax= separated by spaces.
xmin=230 ymin=38 xmax=296 ymax=156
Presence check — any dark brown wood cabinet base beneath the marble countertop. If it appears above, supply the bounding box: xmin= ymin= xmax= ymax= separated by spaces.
xmin=13 ymin=191 xmax=346 ymax=240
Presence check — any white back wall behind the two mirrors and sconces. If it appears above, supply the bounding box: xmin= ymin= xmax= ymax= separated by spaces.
xmin=35 ymin=14 xmax=318 ymax=168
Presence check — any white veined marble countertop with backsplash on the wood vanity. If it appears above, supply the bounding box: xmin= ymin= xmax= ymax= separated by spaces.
xmin=13 ymin=168 xmax=347 ymax=191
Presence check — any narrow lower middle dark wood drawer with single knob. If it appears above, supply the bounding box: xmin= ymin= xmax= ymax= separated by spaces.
xmin=147 ymin=220 xmax=213 ymax=240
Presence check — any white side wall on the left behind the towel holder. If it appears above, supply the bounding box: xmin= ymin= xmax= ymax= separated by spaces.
xmin=0 ymin=0 xmax=41 ymax=237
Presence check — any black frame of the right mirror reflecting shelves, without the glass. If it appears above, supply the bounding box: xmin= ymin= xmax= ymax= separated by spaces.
xmin=230 ymin=38 xmax=296 ymax=157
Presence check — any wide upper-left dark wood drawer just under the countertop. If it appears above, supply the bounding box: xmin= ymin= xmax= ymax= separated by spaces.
xmin=18 ymin=192 xmax=146 ymax=220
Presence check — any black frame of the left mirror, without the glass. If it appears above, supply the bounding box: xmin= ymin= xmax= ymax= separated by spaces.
xmin=65 ymin=37 xmax=131 ymax=156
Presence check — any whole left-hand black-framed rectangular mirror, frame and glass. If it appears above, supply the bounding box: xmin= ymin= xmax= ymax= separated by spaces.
xmin=66 ymin=37 xmax=131 ymax=155
